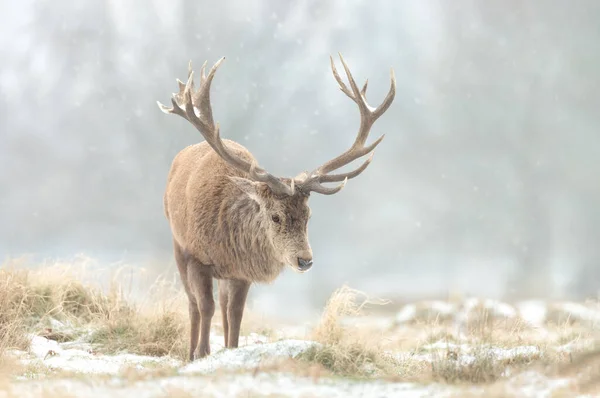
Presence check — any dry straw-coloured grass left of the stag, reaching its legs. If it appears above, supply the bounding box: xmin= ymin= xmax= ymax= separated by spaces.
xmin=0 ymin=256 xmax=187 ymax=359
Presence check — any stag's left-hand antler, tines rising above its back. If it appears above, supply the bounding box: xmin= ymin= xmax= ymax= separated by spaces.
xmin=156 ymin=57 xmax=294 ymax=195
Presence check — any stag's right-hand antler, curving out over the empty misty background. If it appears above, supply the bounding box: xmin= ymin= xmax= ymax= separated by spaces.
xmin=295 ymin=54 xmax=396 ymax=195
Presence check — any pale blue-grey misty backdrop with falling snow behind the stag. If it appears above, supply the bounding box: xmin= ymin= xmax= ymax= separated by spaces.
xmin=0 ymin=0 xmax=600 ymax=313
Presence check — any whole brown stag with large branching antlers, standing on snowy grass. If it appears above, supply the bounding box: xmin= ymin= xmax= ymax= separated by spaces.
xmin=157 ymin=54 xmax=396 ymax=362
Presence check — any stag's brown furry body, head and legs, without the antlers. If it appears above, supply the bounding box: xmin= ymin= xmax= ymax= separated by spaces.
xmin=164 ymin=140 xmax=312 ymax=360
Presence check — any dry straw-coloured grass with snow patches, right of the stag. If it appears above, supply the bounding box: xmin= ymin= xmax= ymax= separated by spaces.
xmin=300 ymin=287 xmax=600 ymax=391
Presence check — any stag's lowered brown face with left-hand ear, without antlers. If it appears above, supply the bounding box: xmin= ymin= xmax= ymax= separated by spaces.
xmin=230 ymin=177 xmax=313 ymax=272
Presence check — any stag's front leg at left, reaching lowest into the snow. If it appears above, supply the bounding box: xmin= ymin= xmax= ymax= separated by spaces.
xmin=187 ymin=261 xmax=215 ymax=359
